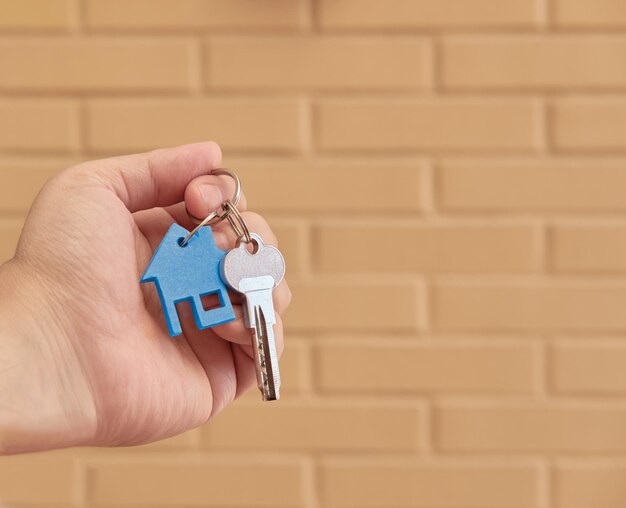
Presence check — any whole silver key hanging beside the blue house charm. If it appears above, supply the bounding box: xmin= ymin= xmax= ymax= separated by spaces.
xmin=222 ymin=233 xmax=285 ymax=400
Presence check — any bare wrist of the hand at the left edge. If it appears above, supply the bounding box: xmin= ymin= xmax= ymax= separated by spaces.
xmin=0 ymin=261 xmax=95 ymax=455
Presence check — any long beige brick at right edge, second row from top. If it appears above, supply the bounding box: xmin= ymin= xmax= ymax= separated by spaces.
xmin=443 ymin=35 xmax=626 ymax=89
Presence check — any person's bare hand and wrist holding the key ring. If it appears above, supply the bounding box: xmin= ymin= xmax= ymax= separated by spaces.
xmin=0 ymin=142 xmax=291 ymax=454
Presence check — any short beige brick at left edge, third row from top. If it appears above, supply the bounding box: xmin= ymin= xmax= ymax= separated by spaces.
xmin=0 ymin=98 xmax=78 ymax=152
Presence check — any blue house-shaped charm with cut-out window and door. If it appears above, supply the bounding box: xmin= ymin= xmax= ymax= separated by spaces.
xmin=141 ymin=224 xmax=235 ymax=337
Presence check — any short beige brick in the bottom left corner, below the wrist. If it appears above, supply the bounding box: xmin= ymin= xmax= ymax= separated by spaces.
xmin=0 ymin=455 xmax=80 ymax=506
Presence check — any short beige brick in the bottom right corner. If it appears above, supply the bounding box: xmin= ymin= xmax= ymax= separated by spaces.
xmin=554 ymin=460 xmax=626 ymax=508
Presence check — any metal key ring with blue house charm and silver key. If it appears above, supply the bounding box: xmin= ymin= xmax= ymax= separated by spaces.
xmin=141 ymin=169 xmax=285 ymax=400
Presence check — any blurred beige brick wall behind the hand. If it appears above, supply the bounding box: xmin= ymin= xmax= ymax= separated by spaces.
xmin=0 ymin=0 xmax=626 ymax=508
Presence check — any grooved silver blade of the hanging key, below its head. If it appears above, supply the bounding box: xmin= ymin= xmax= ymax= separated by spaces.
xmin=252 ymin=306 xmax=280 ymax=400
